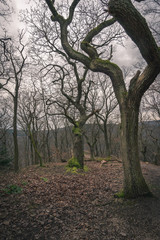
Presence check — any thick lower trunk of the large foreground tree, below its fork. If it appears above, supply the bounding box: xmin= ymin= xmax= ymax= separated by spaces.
xmin=121 ymin=103 xmax=150 ymax=198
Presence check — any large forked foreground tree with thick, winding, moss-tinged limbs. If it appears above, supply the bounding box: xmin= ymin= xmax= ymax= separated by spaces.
xmin=42 ymin=0 xmax=160 ymax=198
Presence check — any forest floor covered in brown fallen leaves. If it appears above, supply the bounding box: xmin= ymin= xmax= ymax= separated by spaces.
xmin=0 ymin=162 xmax=160 ymax=240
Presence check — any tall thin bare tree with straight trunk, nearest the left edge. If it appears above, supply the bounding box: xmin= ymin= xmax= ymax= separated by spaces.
xmin=0 ymin=31 xmax=27 ymax=172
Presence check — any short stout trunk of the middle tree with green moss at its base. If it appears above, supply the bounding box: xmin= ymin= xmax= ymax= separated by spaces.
xmin=73 ymin=134 xmax=84 ymax=169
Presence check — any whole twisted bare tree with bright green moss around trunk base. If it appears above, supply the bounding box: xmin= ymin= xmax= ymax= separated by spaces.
xmin=47 ymin=63 xmax=97 ymax=168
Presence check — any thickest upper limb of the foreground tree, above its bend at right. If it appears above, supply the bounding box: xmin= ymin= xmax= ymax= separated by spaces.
xmin=108 ymin=0 xmax=160 ymax=64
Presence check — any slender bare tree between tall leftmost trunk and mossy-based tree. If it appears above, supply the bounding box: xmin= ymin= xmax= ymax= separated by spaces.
xmin=18 ymin=83 xmax=44 ymax=167
